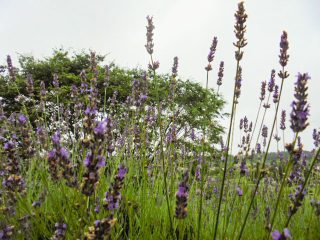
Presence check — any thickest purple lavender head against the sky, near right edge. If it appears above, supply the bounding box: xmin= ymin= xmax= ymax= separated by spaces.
xmin=290 ymin=73 xmax=310 ymax=133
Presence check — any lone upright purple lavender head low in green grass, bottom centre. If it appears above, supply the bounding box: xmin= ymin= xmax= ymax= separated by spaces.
xmin=175 ymin=171 xmax=189 ymax=219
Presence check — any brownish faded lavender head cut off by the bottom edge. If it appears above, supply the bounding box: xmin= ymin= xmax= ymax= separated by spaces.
xmin=84 ymin=217 xmax=116 ymax=240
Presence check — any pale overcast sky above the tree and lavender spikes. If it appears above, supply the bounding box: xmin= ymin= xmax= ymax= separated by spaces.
xmin=0 ymin=0 xmax=320 ymax=153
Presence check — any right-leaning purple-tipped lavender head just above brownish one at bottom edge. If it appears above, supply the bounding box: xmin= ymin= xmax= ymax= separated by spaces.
xmin=103 ymin=164 xmax=128 ymax=211
